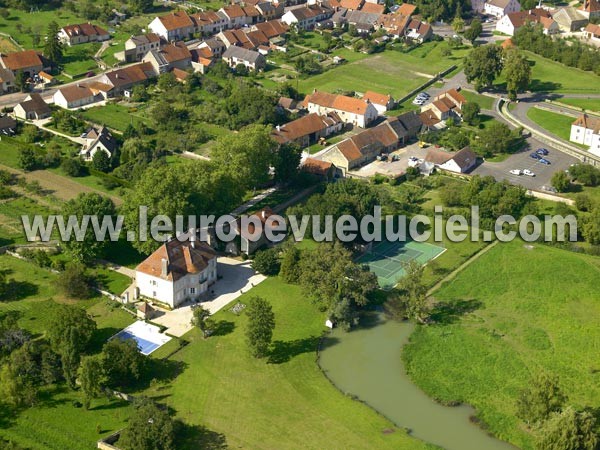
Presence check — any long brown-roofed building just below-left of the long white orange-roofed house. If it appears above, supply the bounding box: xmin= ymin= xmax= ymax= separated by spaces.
xmin=271 ymin=112 xmax=344 ymax=148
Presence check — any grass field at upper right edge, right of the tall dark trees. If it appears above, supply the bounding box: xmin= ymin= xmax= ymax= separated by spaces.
xmin=496 ymin=52 xmax=600 ymax=94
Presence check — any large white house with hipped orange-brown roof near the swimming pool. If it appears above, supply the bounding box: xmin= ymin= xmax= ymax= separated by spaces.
xmin=135 ymin=233 xmax=217 ymax=308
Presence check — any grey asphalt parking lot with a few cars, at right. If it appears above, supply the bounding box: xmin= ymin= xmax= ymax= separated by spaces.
xmin=471 ymin=138 xmax=579 ymax=191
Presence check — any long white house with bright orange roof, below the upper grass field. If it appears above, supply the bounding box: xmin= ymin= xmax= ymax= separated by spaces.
xmin=304 ymin=90 xmax=378 ymax=128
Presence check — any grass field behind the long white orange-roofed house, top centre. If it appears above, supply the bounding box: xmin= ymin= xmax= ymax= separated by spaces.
xmin=290 ymin=43 xmax=465 ymax=98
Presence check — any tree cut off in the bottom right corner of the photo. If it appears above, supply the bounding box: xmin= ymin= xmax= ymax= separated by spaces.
xmin=536 ymin=406 xmax=598 ymax=450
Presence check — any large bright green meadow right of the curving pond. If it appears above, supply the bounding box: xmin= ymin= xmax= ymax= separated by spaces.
xmin=403 ymin=242 xmax=600 ymax=449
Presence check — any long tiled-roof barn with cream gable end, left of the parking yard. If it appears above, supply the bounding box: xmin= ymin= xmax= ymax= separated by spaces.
xmin=321 ymin=122 xmax=400 ymax=173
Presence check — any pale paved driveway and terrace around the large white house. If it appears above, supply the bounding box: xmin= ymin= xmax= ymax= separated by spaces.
xmin=152 ymin=257 xmax=267 ymax=337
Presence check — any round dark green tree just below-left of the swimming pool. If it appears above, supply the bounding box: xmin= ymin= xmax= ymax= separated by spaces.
xmin=102 ymin=339 xmax=147 ymax=387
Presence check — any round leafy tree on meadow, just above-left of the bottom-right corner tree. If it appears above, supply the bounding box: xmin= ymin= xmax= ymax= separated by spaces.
xmin=517 ymin=372 xmax=566 ymax=424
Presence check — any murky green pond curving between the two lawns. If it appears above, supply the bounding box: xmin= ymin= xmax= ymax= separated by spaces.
xmin=319 ymin=314 xmax=515 ymax=450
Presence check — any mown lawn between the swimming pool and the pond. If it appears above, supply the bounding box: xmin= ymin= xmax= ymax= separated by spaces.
xmin=145 ymin=278 xmax=432 ymax=449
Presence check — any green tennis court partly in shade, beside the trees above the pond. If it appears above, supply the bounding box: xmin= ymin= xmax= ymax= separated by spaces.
xmin=356 ymin=241 xmax=446 ymax=289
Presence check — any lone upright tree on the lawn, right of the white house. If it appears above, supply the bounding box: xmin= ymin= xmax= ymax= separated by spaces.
xmin=246 ymin=297 xmax=275 ymax=358
